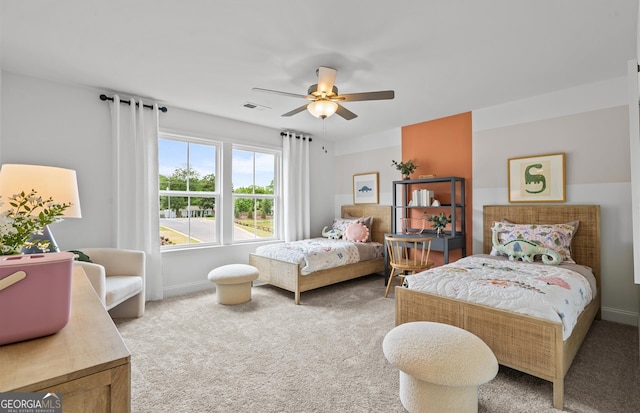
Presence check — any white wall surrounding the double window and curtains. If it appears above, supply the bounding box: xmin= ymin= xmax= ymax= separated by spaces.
xmin=0 ymin=72 xmax=334 ymax=296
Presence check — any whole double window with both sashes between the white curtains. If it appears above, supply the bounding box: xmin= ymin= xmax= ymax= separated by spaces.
xmin=158 ymin=134 xmax=280 ymax=249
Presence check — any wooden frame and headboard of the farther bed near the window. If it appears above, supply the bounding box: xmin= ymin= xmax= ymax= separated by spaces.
xmin=249 ymin=205 xmax=391 ymax=304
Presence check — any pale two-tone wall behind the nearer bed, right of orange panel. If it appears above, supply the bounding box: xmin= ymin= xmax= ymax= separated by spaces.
xmin=473 ymin=77 xmax=640 ymax=325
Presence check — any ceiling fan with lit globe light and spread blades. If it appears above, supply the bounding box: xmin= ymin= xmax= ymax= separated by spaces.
xmin=253 ymin=66 xmax=395 ymax=120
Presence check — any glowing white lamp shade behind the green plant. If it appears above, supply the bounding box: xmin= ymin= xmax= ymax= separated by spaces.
xmin=0 ymin=164 xmax=82 ymax=218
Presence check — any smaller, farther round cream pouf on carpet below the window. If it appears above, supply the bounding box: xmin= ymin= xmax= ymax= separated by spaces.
xmin=208 ymin=264 xmax=260 ymax=304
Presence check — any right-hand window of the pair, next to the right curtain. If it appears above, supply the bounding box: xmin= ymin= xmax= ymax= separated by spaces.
xmin=232 ymin=147 xmax=277 ymax=241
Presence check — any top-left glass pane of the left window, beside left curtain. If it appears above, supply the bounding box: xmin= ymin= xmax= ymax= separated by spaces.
xmin=158 ymin=139 xmax=188 ymax=191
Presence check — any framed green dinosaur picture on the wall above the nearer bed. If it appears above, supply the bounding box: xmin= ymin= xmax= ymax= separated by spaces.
xmin=508 ymin=153 xmax=566 ymax=202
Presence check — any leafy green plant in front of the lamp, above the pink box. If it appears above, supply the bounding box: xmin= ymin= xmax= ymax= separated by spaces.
xmin=0 ymin=190 xmax=71 ymax=255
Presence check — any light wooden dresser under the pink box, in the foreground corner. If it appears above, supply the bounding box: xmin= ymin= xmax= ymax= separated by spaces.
xmin=0 ymin=266 xmax=131 ymax=413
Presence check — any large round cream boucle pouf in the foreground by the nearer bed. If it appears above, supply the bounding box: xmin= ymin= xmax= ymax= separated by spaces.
xmin=382 ymin=321 xmax=498 ymax=413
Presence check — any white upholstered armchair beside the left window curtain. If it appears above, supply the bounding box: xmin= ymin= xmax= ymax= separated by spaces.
xmin=74 ymin=248 xmax=145 ymax=318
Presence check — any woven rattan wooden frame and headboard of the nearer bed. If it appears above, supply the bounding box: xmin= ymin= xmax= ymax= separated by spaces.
xmin=395 ymin=205 xmax=600 ymax=410
